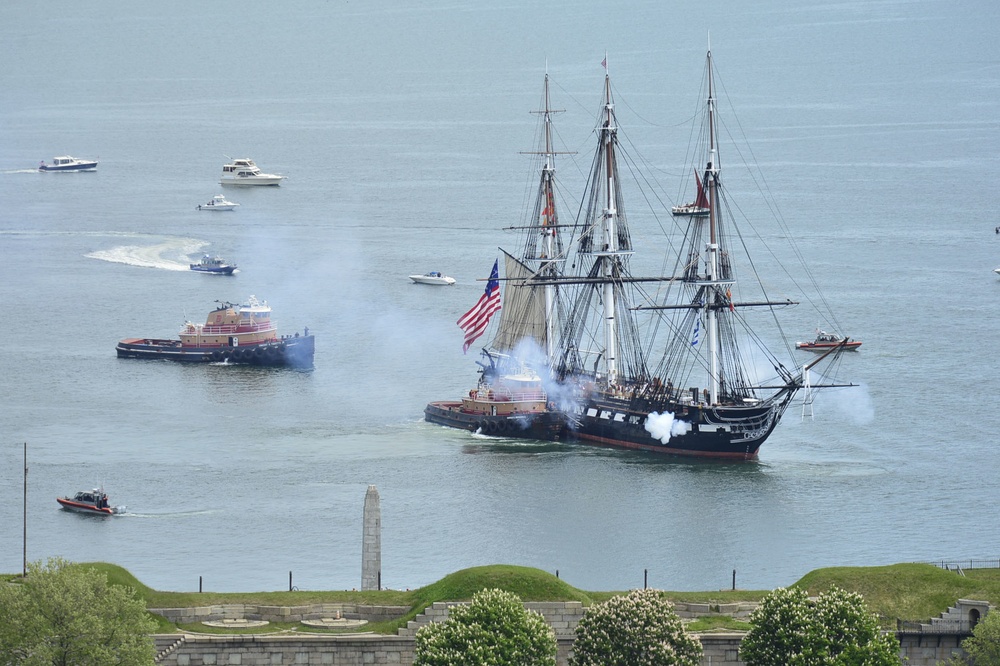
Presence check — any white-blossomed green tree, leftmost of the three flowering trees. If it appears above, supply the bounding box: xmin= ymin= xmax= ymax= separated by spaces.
xmin=413 ymin=590 xmax=556 ymax=666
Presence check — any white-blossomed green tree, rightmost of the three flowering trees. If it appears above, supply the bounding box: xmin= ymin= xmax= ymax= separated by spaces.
xmin=740 ymin=587 xmax=900 ymax=666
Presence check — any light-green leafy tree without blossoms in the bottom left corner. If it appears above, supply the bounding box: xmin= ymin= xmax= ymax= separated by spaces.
xmin=0 ymin=558 xmax=156 ymax=666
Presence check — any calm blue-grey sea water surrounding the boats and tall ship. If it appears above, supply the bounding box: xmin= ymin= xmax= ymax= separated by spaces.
xmin=0 ymin=0 xmax=1000 ymax=591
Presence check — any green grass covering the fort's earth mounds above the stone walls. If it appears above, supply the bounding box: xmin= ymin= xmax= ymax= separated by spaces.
xmin=21 ymin=562 xmax=1000 ymax=634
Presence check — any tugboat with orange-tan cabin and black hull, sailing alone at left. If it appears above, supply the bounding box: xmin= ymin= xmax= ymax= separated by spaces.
xmin=115 ymin=296 xmax=315 ymax=368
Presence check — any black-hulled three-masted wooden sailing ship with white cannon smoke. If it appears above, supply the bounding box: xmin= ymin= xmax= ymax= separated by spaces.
xmin=425 ymin=52 xmax=845 ymax=460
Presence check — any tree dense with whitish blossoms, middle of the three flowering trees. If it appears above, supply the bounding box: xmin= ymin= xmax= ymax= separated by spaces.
xmin=570 ymin=590 xmax=702 ymax=666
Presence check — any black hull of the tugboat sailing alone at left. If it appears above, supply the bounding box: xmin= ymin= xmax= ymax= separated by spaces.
xmin=115 ymin=335 xmax=315 ymax=369
